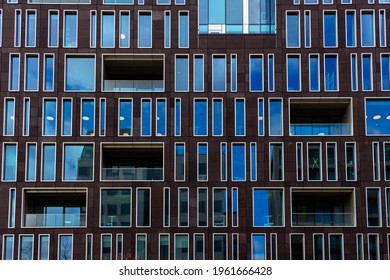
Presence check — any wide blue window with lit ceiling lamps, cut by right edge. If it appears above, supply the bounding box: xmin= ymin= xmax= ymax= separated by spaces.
xmin=366 ymin=99 xmax=390 ymax=135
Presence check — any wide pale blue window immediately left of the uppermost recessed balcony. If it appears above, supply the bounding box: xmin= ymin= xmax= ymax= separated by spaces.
xmin=65 ymin=57 xmax=95 ymax=91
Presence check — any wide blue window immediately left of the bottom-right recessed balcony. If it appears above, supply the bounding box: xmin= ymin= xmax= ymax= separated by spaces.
xmin=252 ymin=189 xmax=284 ymax=227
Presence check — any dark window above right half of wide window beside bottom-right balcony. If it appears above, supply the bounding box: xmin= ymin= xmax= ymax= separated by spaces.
xmin=269 ymin=143 xmax=284 ymax=181
